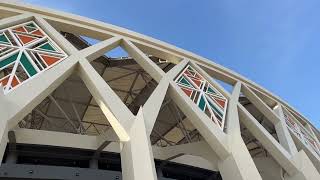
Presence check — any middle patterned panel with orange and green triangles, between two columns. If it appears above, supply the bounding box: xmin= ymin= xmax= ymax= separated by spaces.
xmin=175 ymin=65 xmax=228 ymax=129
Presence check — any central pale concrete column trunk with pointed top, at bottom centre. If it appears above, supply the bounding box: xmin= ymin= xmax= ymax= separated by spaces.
xmin=121 ymin=108 xmax=157 ymax=180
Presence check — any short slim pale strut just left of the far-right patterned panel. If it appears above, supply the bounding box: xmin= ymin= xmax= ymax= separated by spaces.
xmin=274 ymin=104 xmax=298 ymax=154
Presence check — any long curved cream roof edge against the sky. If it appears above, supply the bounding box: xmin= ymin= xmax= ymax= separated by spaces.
xmin=0 ymin=0 xmax=320 ymax=134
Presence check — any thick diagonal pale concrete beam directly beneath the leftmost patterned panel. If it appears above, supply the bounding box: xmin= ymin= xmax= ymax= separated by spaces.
xmin=6 ymin=56 xmax=78 ymax=129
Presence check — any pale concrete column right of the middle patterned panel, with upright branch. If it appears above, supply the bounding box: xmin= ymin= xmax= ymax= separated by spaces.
xmin=219 ymin=82 xmax=262 ymax=180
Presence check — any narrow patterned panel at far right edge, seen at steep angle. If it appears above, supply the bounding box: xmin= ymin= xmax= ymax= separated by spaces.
xmin=283 ymin=111 xmax=320 ymax=156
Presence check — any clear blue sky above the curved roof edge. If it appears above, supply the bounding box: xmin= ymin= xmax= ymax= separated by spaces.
xmin=25 ymin=0 xmax=320 ymax=128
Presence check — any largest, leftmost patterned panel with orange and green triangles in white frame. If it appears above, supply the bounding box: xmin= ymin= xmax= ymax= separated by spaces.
xmin=0 ymin=21 xmax=67 ymax=93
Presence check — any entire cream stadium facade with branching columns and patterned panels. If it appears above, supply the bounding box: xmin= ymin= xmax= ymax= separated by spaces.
xmin=0 ymin=1 xmax=320 ymax=180
